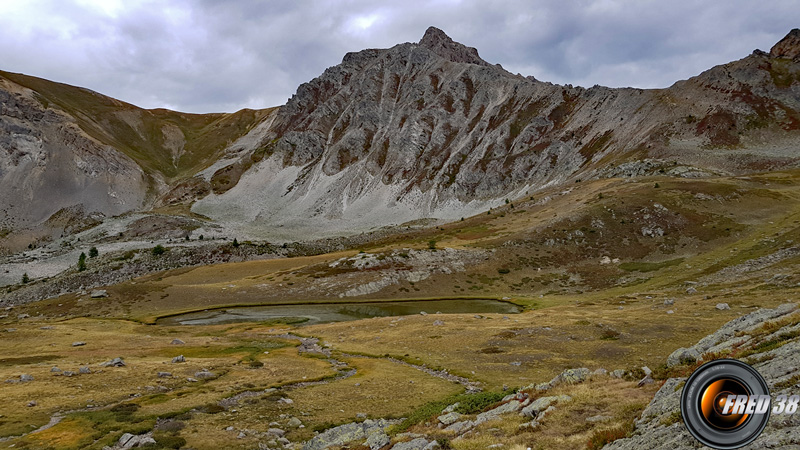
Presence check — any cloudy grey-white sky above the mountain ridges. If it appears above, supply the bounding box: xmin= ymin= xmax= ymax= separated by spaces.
xmin=0 ymin=0 xmax=800 ymax=112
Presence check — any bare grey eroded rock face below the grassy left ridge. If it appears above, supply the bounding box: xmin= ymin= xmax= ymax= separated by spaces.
xmin=0 ymin=77 xmax=149 ymax=234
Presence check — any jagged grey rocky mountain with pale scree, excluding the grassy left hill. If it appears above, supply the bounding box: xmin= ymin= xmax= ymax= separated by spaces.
xmin=193 ymin=28 xmax=800 ymax=238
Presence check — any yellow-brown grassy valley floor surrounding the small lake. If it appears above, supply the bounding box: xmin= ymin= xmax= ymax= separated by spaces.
xmin=0 ymin=173 xmax=800 ymax=450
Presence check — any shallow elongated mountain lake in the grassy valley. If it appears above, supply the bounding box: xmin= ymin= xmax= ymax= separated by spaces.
xmin=158 ymin=299 xmax=520 ymax=325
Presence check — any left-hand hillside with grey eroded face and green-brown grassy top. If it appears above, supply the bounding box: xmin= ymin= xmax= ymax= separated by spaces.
xmin=0 ymin=71 xmax=271 ymax=250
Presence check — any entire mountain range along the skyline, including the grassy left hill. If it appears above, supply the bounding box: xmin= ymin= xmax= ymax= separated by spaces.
xmin=0 ymin=27 xmax=800 ymax=249
